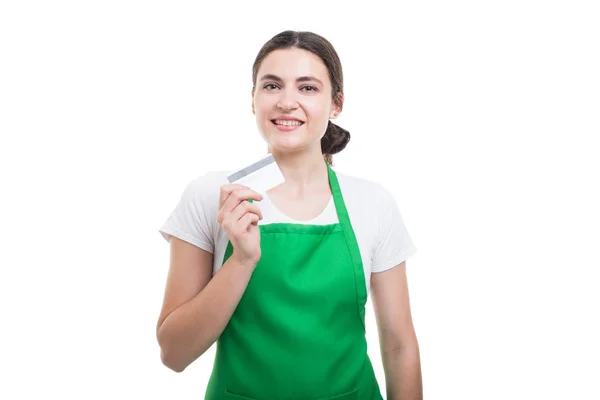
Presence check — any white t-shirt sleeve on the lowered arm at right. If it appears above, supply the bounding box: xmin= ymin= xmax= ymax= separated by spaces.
xmin=371 ymin=187 xmax=417 ymax=272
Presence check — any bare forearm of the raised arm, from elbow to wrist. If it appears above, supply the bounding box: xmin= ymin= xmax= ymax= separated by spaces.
xmin=158 ymin=258 xmax=254 ymax=372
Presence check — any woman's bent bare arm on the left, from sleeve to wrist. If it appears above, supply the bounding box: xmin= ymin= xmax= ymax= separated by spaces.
xmin=156 ymin=237 xmax=254 ymax=372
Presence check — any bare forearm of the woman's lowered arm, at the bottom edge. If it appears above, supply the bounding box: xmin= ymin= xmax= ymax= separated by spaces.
xmin=382 ymin=343 xmax=423 ymax=400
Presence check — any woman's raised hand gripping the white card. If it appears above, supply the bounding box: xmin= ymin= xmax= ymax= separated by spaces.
xmin=217 ymin=184 xmax=263 ymax=267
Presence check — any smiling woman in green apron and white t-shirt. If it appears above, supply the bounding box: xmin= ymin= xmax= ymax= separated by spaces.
xmin=157 ymin=31 xmax=422 ymax=400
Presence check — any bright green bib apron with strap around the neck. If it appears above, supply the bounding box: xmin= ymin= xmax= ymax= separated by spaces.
xmin=205 ymin=165 xmax=382 ymax=400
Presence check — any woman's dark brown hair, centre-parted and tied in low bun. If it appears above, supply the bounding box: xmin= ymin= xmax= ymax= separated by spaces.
xmin=252 ymin=31 xmax=350 ymax=165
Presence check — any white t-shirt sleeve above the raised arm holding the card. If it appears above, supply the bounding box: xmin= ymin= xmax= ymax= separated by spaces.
xmin=159 ymin=174 xmax=219 ymax=253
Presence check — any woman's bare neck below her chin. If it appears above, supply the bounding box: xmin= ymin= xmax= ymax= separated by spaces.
xmin=271 ymin=146 xmax=329 ymax=195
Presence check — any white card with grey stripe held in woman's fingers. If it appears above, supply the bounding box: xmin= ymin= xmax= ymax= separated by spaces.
xmin=227 ymin=154 xmax=285 ymax=194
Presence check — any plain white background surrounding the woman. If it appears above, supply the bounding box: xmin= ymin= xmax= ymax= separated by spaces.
xmin=0 ymin=0 xmax=600 ymax=400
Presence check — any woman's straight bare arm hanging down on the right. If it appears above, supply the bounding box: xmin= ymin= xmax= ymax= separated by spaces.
xmin=371 ymin=262 xmax=423 ymax=400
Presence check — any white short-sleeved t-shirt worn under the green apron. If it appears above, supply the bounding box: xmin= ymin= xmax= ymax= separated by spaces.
xmin=159 ymin=171 xmax=417 ymax=291
